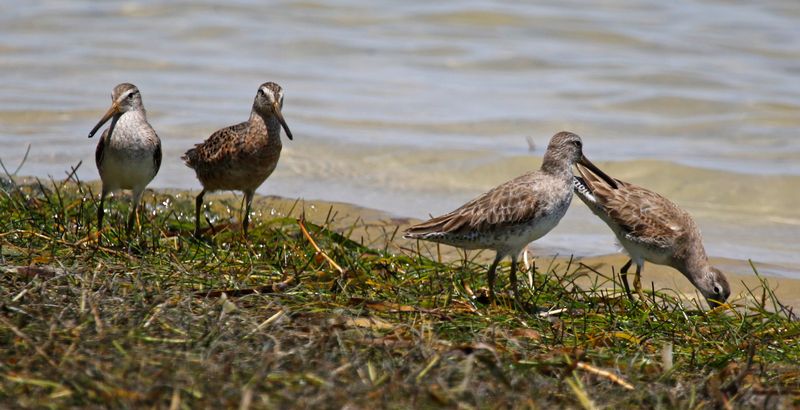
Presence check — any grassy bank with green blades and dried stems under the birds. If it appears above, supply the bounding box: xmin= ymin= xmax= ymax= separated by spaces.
xmin=0 ymin=175 xmax=800 ymax=409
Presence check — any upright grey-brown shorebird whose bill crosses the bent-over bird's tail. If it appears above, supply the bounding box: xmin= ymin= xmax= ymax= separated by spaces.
xmin=404 ymin=131 xmax=614 ymax=302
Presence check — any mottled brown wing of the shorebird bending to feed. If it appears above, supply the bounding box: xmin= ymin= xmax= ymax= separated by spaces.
xmin=578 ymin=165 xmax=695 ymax=247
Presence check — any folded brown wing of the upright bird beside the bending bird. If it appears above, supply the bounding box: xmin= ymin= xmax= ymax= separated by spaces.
xmin=406 ymin=174 xmax=538 ymax=238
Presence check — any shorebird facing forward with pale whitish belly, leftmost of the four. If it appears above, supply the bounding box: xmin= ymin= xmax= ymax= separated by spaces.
xmin=89 ymin=83 xmax=161 ymax=233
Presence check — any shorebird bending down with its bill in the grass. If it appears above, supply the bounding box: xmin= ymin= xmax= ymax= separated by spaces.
xmin=574 ymin=165 xmax=731 ymax=308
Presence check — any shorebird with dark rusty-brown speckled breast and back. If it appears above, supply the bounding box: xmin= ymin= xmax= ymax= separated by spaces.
xmin=182 ymin=82 xmax=292 ymax=238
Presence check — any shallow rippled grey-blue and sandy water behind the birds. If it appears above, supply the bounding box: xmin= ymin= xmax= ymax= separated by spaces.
xmin=0 ymin=0 xmax=800 ymax=278
